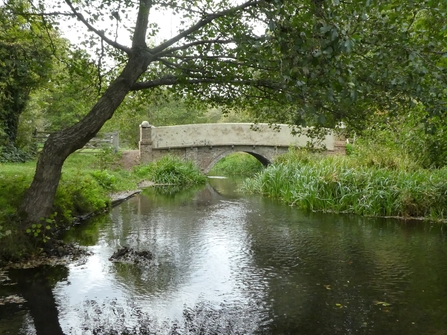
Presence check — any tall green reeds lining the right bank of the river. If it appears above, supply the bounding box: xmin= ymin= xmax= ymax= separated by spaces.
xmin=243 ymin=151 xmax=447 ymax=219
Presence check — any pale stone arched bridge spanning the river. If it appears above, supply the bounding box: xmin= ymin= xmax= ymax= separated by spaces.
xmin=140 ymin=121 xmax=345 ymax=173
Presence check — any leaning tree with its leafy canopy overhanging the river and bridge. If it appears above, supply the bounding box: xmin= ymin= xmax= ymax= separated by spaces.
xmin=14 ymin=0 xmax=446 ymax=226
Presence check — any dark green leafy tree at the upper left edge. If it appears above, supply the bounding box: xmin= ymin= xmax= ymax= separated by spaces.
xmin=0 ymin=1 xmax=52 ymax=146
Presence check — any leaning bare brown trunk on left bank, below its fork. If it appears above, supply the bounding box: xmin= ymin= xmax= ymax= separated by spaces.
xmin=20 ymin=50 xmax=149 ymax=227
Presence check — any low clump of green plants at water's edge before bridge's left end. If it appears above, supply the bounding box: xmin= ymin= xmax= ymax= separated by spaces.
xmin=135 ymin=155 xmax=206 ymax=186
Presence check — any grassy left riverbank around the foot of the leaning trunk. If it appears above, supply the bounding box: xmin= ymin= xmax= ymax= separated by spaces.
xmin=0 ymin=152 xmax=206 ymax=260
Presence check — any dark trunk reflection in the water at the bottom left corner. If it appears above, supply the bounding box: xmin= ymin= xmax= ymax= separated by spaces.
xmin=10 ymin=266 xmax=68 ymax=335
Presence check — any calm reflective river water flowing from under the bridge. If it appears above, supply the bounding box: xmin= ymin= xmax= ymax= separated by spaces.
xmin=0 ymin=179 xmax=447 ymax=335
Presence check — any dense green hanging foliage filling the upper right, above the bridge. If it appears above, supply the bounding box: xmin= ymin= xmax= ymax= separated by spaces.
xmin=241 ymin=0 xmax=446 ymax=129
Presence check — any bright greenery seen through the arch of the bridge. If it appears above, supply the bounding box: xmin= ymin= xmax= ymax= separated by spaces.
xmin=209 ymin=153 xmax=264 ymax=176
